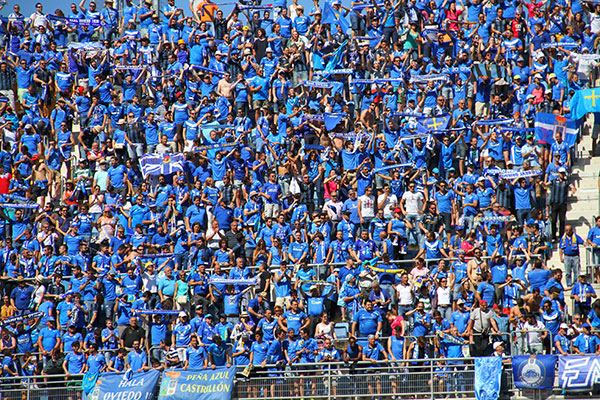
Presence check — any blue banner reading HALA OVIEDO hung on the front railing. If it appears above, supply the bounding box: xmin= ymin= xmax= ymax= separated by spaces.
xmin=89 ymin=370 xmax=160 ymax=400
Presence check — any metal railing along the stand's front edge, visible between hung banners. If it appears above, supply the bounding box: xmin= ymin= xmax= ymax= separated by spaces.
xmin=0 ymin=358 xmax=515 ymax=400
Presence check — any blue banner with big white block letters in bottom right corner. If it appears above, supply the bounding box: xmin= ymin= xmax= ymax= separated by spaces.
xmin=558 ymin=355 xmax=600 ymax=391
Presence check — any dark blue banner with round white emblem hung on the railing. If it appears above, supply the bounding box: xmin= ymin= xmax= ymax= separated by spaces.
xmin=512 ymin=354 xmax=557 ymax=390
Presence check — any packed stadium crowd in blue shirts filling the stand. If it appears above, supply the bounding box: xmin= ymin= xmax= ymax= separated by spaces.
xmin=0 ymin=0 xmax=600 ymax=394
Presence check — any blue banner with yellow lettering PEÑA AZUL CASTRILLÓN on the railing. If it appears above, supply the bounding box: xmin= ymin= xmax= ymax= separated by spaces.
xmin=158 ymin=367 xmax=235 ymax=400
